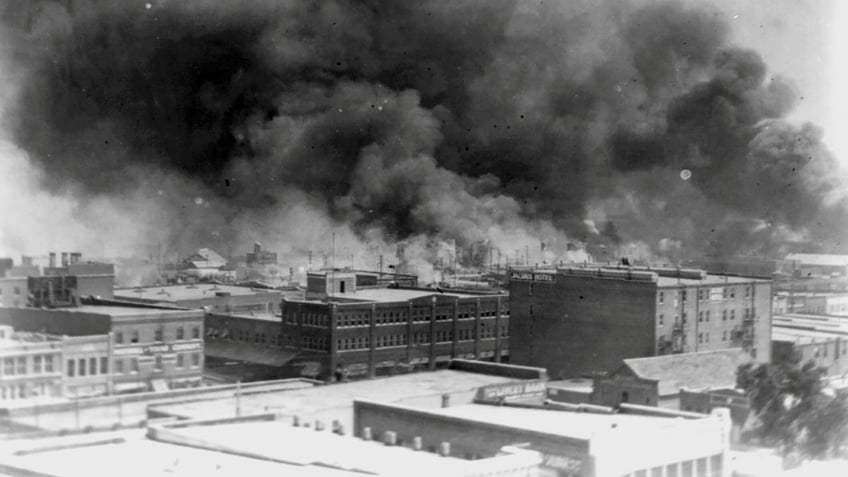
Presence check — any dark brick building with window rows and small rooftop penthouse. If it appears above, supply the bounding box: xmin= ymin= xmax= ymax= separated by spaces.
xmin=281 ymin=272 xmax=509 ymax=379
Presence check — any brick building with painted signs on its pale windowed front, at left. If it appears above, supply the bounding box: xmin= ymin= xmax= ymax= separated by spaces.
xmin=0 ymin=305 xmax=204 ymax=394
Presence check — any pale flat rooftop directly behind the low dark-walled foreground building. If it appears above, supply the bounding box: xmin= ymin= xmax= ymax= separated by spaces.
xmin=151 ymin=369 xmax=528 ymax=429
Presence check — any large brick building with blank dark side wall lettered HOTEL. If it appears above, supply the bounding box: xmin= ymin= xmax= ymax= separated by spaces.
xmin=509 ymin=267 xmax=771 ymax=379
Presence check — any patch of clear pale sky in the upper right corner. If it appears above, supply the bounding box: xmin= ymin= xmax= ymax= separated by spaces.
xmin=691 ymin=0 xmax=848 ymax=160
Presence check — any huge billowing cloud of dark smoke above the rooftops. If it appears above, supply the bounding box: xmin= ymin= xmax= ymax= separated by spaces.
xmin=0 ymin=0 xmax=846 ymax=267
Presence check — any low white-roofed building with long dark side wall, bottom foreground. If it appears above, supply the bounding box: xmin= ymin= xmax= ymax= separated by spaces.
xmin=354 ymin=400 xmax=731 ymax=477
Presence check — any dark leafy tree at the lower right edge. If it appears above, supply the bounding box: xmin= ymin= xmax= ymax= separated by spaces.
xmin=736 ymin=357 xmax=848 ymax=459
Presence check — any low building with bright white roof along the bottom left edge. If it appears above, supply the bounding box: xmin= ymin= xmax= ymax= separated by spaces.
xmin=0 ymin=415 xmax=541 ymax=477
